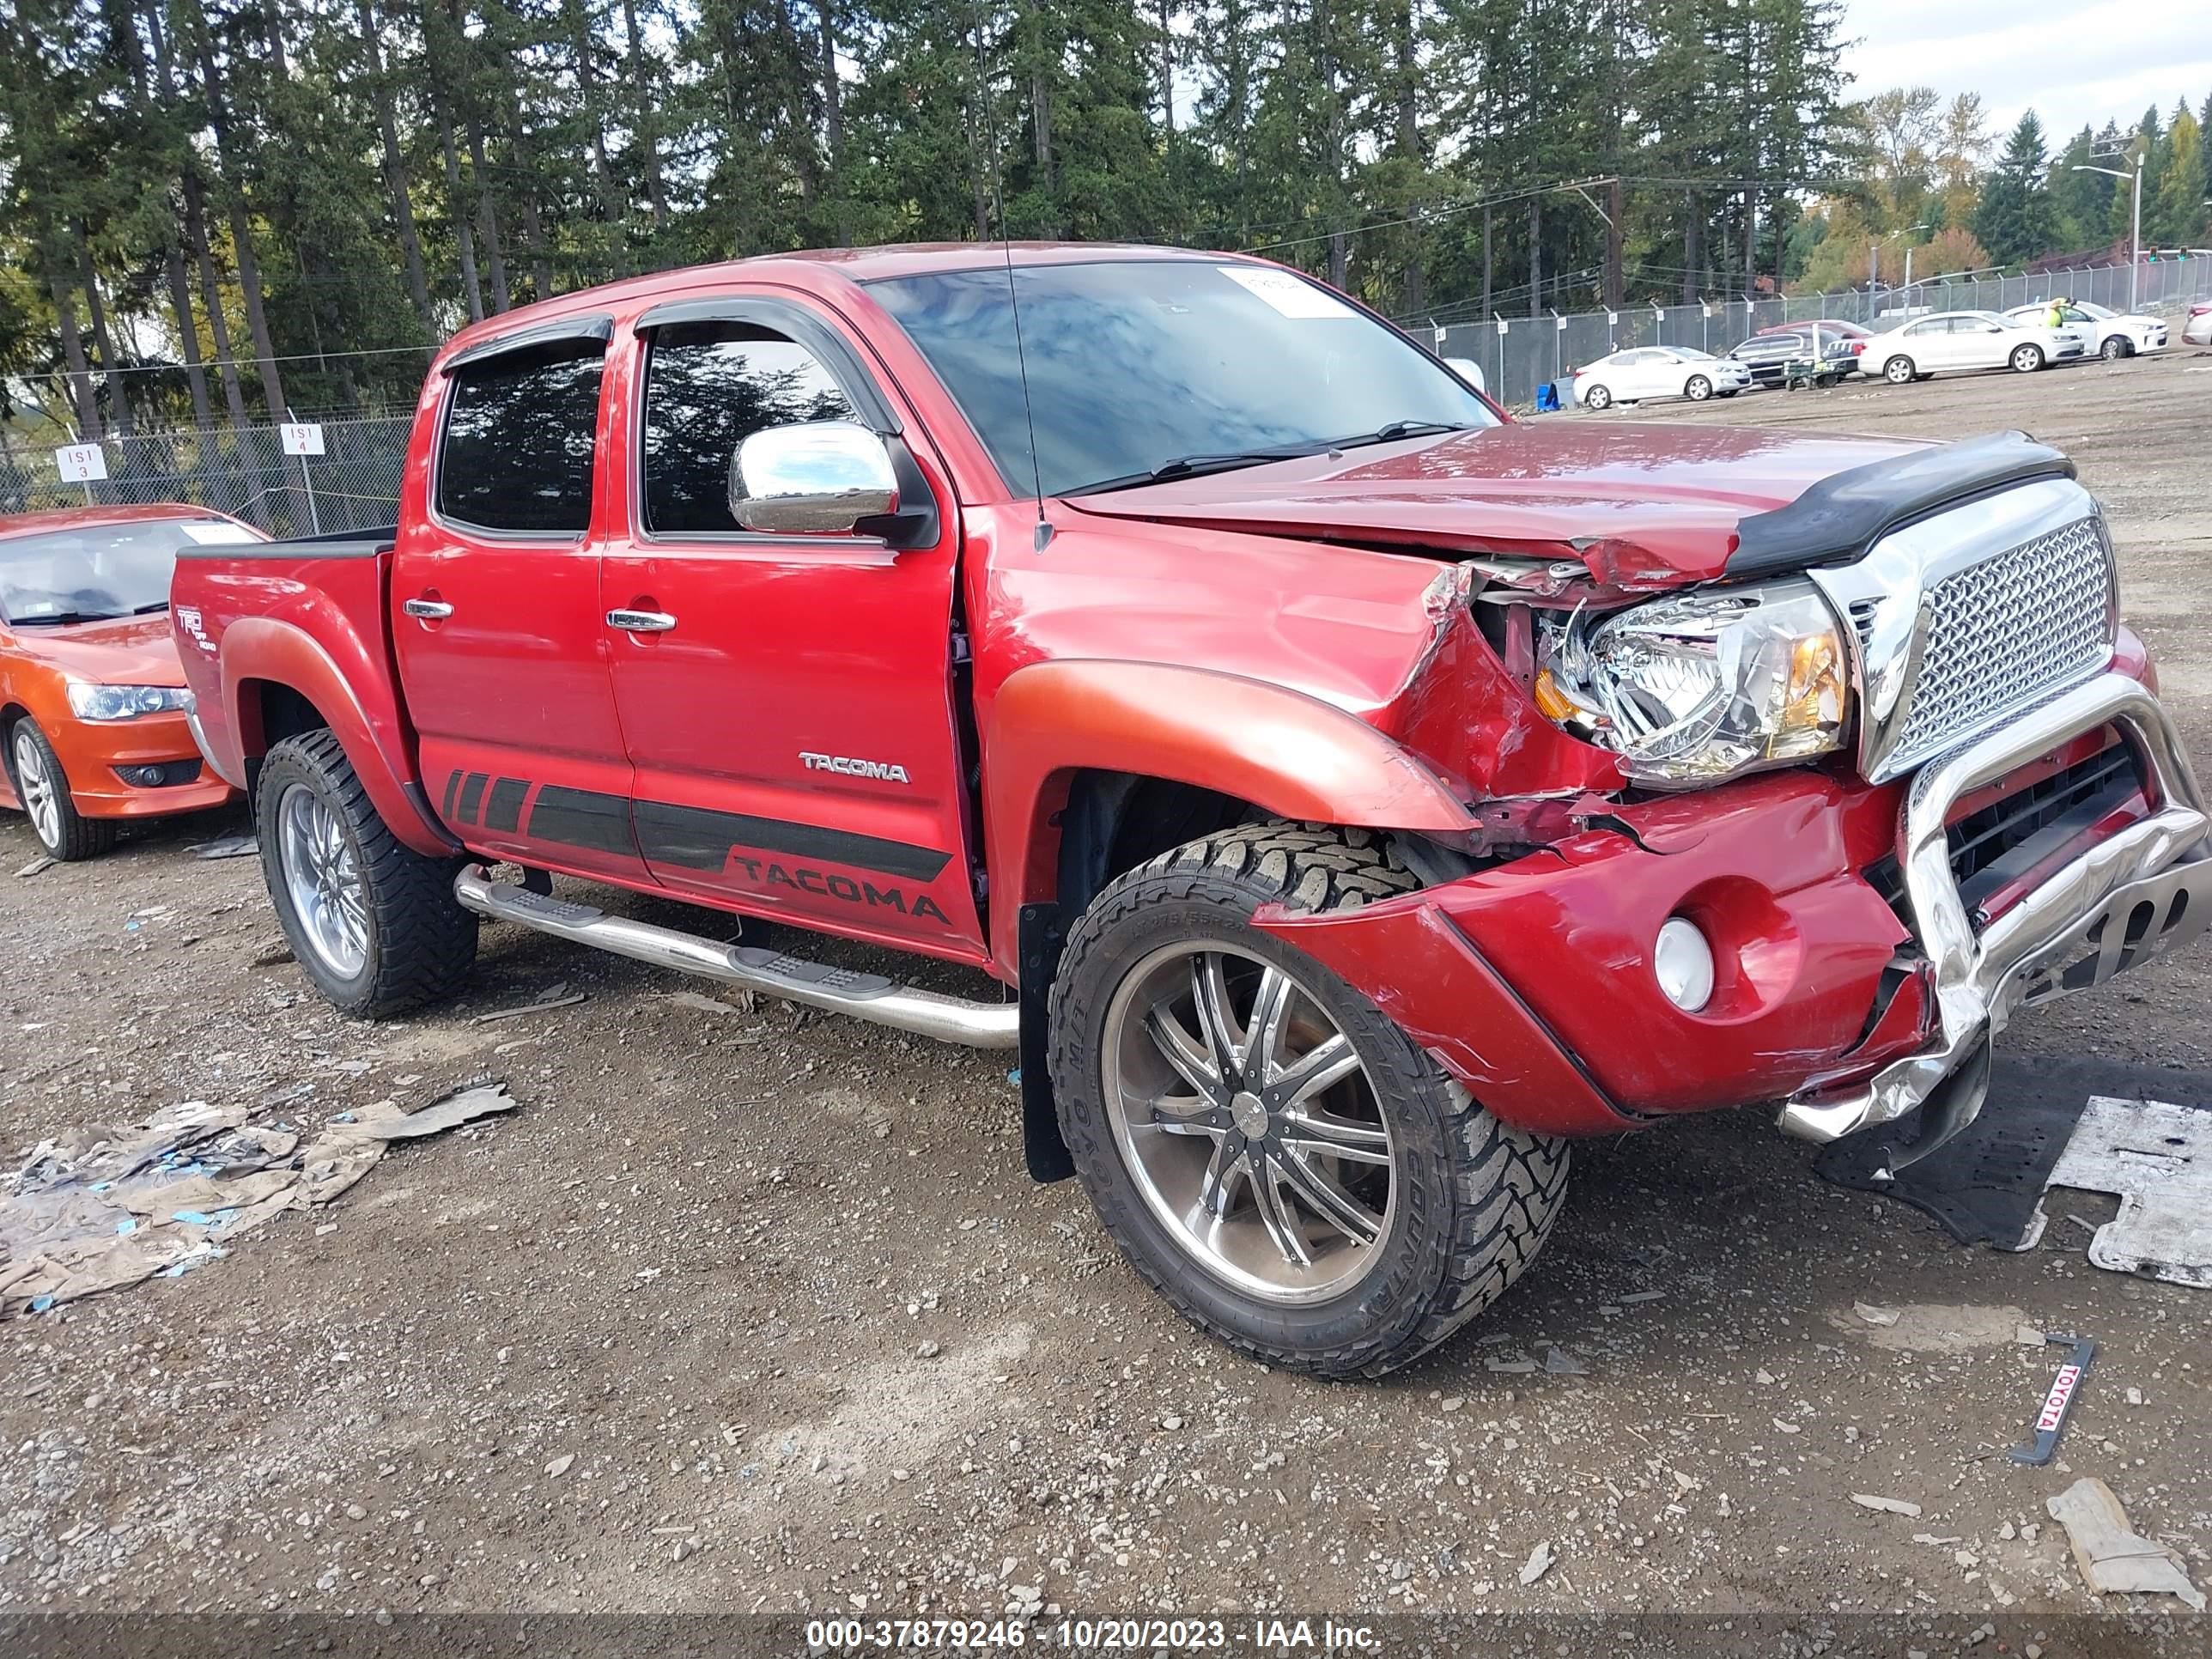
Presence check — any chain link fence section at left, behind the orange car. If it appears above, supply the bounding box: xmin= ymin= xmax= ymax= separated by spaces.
xmin=0 ymin=416 xmax=414 ymax=535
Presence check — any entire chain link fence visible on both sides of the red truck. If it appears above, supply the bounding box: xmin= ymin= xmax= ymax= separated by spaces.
xmin=0 ymin=254 xmax=2212 ymax=513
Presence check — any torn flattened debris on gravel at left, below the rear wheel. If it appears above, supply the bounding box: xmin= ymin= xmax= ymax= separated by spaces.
xmin=0 ymin=1082 xmax=515 ymax=1318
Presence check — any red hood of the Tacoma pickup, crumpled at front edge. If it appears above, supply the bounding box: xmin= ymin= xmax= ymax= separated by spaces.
xmin=1066 ymin=420 xmax=1927 ymax=591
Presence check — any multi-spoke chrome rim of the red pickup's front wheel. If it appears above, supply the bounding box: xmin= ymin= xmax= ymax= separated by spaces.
xmin=1103 ymin=940 xmax=1395 ymax=1303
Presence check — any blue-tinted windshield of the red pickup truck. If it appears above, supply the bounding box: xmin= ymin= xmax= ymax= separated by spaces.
xmin=869 ymin=258 xmax=1498 ymax=495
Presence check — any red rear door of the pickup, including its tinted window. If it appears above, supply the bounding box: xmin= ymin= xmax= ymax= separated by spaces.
xmin=392 ymin=316 xmax=648 ymax=884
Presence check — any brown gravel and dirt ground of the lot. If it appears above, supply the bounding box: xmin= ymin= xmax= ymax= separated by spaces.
xmin=0 ymin=349 xmax=2212 ymax=1614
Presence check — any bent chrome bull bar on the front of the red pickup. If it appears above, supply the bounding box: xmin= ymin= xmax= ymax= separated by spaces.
xmin=1781 ymin=672 xmax=2212 ymax=1168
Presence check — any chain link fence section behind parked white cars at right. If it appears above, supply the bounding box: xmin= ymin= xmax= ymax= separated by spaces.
xmin=1416 ymin=254 xmax=2212 ymax=417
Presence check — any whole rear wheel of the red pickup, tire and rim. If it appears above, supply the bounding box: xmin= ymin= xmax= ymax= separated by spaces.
xmin=254 ymin=730 xmax=476 ymax=1020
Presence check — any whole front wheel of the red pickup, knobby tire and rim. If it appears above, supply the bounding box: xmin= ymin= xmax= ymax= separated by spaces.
xmin=1051 ymin=823 xmax=1568 ymax=1378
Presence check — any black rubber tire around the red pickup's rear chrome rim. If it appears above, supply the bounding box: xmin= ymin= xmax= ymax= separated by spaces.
xmin=254 ymin=730 xmax=477 ymax=1020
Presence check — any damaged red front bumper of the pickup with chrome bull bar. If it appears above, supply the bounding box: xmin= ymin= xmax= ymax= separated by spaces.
xmin=1255 ymin=671 xmax=2212 ymax=1146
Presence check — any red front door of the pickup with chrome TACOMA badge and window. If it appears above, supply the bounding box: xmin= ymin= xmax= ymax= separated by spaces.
xmin=602 ymin=295 xmax=982 ymax=957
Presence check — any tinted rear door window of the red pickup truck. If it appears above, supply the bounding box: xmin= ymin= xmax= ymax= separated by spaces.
xmin=438 ymin=341 xmax=606 ymax=535
